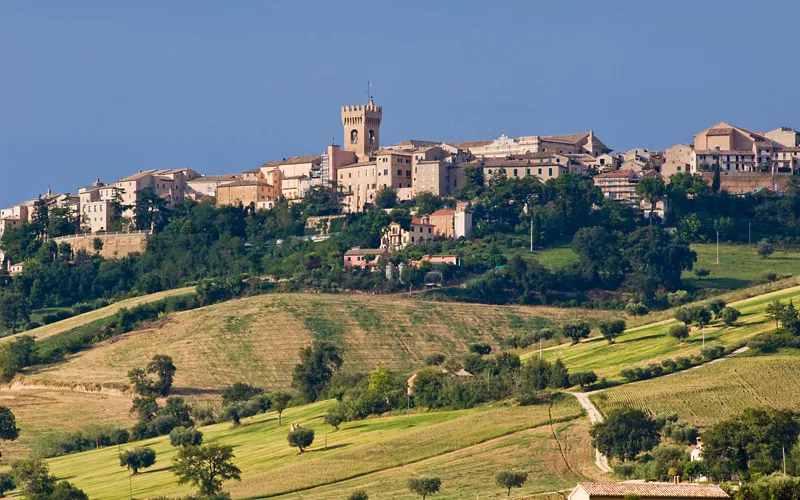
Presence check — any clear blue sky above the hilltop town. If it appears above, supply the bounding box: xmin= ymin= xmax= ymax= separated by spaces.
xmin=0 ymin=0 xmax=800 ymax=206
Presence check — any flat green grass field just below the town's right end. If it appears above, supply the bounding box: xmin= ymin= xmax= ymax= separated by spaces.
xmin=683 ymin=243 xmax=800 ymax=290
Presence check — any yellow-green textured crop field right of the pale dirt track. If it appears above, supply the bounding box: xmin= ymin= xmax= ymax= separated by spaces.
xmin=592 ymin=351 xmax=800 ymax=427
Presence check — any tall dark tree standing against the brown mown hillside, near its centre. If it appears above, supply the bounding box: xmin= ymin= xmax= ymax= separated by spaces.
xmin=292 ymin=340 xmax=342 ymax=402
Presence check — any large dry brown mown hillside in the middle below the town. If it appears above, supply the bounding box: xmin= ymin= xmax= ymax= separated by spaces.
xmin=25 ymin=294 xmax=608 ymax=395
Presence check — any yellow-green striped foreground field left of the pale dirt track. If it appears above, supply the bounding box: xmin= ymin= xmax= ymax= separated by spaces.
xmin=12 ymin=396 xmax=593 ymax=500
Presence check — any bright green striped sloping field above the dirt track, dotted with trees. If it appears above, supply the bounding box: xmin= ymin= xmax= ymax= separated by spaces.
xmin=523 ymin=287 xmax=800 ymax=380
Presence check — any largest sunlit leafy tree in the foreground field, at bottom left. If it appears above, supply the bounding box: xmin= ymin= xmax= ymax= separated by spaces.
xmin=171 ymin=443 xmax=242 ymax=495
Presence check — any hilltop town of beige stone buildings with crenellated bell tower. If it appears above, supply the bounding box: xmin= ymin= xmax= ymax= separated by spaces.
xmin=0 ymin=98 xmax=800 ymax=274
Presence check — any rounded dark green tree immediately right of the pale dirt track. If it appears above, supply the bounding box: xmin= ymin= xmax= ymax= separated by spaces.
xmin=590 ymin=408 xmax=660 ymax=460
